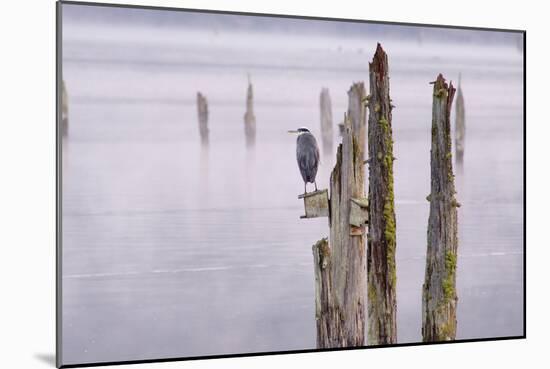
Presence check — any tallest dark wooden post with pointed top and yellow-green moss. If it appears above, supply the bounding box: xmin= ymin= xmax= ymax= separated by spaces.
xmin=367 ymin=44 xmax=397 ymax=345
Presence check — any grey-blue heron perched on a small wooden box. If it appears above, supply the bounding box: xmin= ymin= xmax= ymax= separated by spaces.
xmin=288 ymin=127 xmax=319 ymax=193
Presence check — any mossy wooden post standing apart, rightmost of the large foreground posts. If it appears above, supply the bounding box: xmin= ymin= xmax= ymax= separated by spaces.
xmin=422 ymin=74 xmax=460 ymax=342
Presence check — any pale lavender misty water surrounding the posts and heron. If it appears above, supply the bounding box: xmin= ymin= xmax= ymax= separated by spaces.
xmin=62 ymin=5 xmax=523 ymax=364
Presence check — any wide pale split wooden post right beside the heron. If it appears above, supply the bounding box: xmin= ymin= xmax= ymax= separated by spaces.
xmin=313 ymin=83 xmax=367 ymax=348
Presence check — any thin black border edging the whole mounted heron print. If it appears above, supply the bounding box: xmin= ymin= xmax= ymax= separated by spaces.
xmin=55 ymin=0 xmax=527 ymax=368
